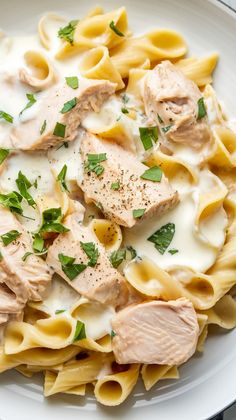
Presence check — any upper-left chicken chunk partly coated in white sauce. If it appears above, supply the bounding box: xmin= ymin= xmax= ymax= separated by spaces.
xmin=11 ymin=79 xmax=116 ymax=150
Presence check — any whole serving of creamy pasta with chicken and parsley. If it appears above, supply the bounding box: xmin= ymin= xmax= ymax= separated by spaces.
xmin=0 ymin=7 xmax=236 ymax=406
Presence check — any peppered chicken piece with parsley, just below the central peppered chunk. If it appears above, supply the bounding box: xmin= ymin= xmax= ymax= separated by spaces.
xmin=46 ymin=213 xmax=128 ymax=306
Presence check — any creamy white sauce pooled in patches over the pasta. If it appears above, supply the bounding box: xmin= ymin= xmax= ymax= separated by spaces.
xmin=0 ymin=23 xmax=230 ymax=324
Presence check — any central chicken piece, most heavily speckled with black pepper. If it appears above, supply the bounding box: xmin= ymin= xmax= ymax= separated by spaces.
xmin=78 ymin=133 xmax=178 ymax=227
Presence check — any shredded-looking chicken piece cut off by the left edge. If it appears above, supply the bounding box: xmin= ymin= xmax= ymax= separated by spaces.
xmin=0 ymin=207 xmax=51 ymax=304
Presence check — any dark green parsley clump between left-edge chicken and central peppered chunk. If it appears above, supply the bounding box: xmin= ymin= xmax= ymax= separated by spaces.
xmin=39 ymin=207 xmax=70 ymax=233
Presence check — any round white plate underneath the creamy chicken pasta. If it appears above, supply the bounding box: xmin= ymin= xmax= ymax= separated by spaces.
xmin=0 ymin=0 xmax=236 ymax=420
